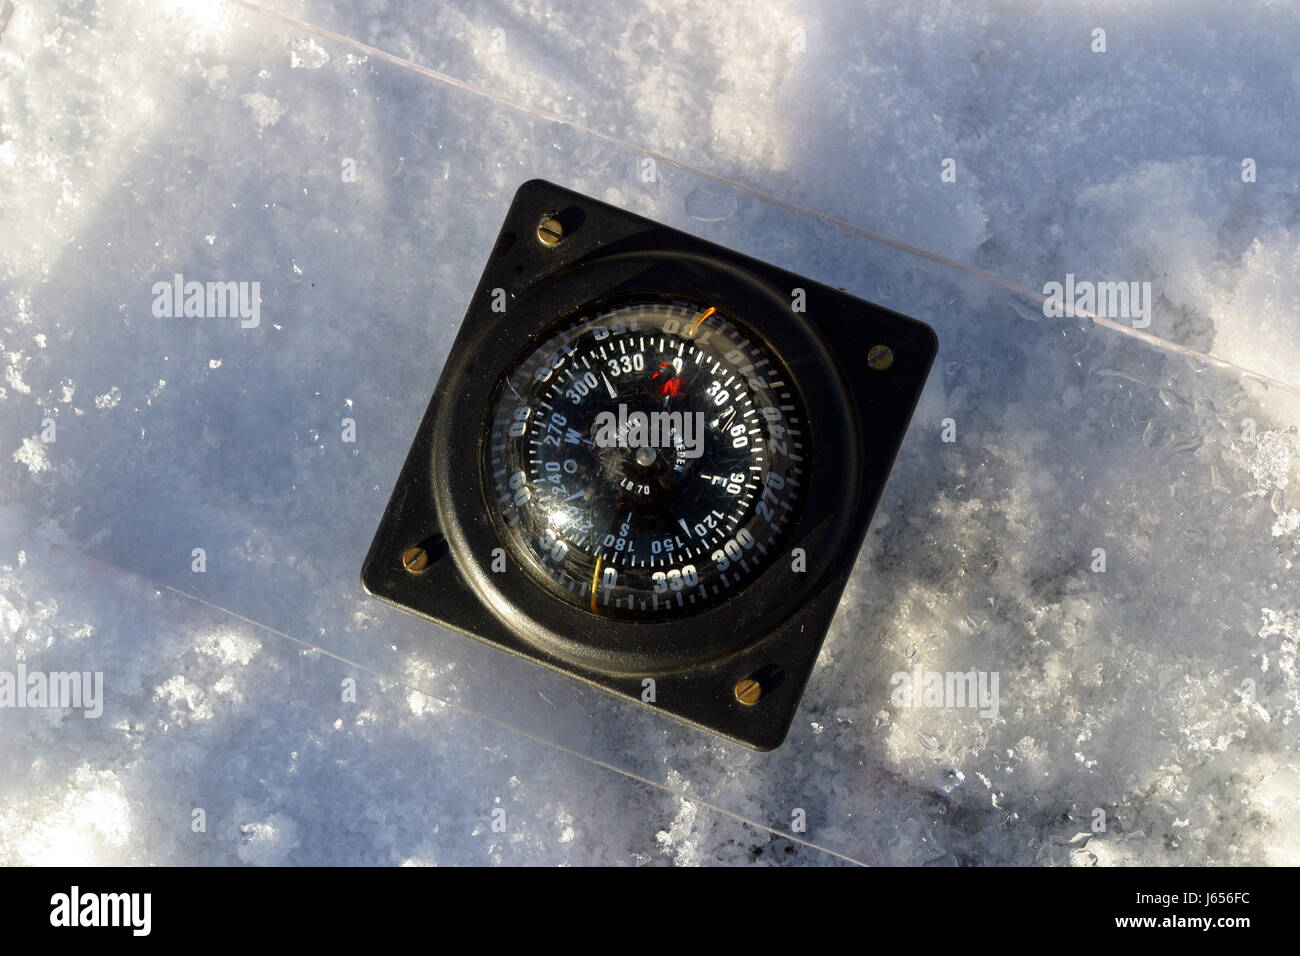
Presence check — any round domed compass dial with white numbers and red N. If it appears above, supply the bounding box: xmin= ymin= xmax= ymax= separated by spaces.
xmin=482 ymin=299 xmax=809 ymax=619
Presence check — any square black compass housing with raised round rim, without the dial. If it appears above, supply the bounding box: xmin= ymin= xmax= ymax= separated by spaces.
xmin=361 ymin=179 xmax=937 ymax=750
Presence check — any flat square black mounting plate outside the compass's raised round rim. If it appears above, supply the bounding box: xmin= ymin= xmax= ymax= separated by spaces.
xmin=361 ymin=179 xmax=937 ymax=750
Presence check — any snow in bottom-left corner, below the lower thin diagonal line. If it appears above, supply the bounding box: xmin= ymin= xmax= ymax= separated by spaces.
xmin=0 ymin=538 xmax=839 ymax=865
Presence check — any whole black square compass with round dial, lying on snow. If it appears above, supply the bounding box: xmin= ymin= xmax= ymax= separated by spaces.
xmin=361 ymin=181 xmax=936 ymax=749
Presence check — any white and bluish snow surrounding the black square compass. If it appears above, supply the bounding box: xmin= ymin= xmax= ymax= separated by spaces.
xmin=0 ymin=0 xmax=1300 ymax=865
